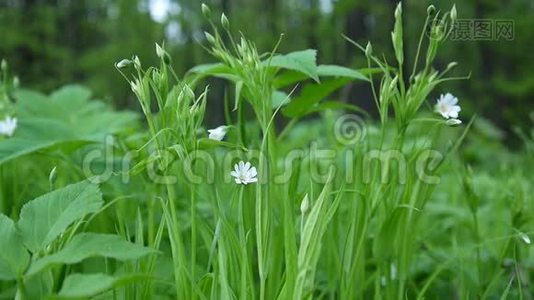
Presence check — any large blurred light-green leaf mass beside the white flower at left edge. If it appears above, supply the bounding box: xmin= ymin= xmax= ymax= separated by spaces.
xmin=0 ymin=85 xmax=137 ymax=164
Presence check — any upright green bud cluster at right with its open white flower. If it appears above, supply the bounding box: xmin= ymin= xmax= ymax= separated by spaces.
xmin=349 ymin=3 xmax=461 ymax=135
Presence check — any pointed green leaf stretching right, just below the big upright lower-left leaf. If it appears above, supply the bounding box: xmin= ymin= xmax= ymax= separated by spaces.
xmin=27 ymin=233 xmax=156 ymax=275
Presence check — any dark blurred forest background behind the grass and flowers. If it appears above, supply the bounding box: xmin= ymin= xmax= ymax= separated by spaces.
xmin=0 ymin=0 xmax=534 ymax=144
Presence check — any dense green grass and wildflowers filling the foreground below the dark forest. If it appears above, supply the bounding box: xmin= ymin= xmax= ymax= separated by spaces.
xmin=0 ymin=5 xmax=534 ymax=299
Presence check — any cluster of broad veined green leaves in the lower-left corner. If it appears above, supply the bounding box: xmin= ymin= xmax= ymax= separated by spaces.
xmin=0 ymin=181 xmax=156 ymax=299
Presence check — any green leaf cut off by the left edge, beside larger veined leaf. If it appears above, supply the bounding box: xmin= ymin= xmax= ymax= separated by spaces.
xmin=0 ymin=214 xmax=30 ymax=280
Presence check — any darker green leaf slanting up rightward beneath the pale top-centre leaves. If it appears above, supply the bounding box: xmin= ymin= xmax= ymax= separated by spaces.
xmin=282 ymin=78 xmax=350 ymax=118
